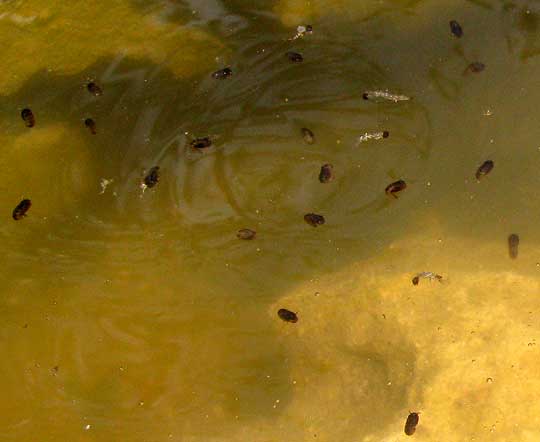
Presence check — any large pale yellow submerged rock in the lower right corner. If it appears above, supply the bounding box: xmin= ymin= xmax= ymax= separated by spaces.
xmin=260 ymin=231 xmax=540 ymax=442
